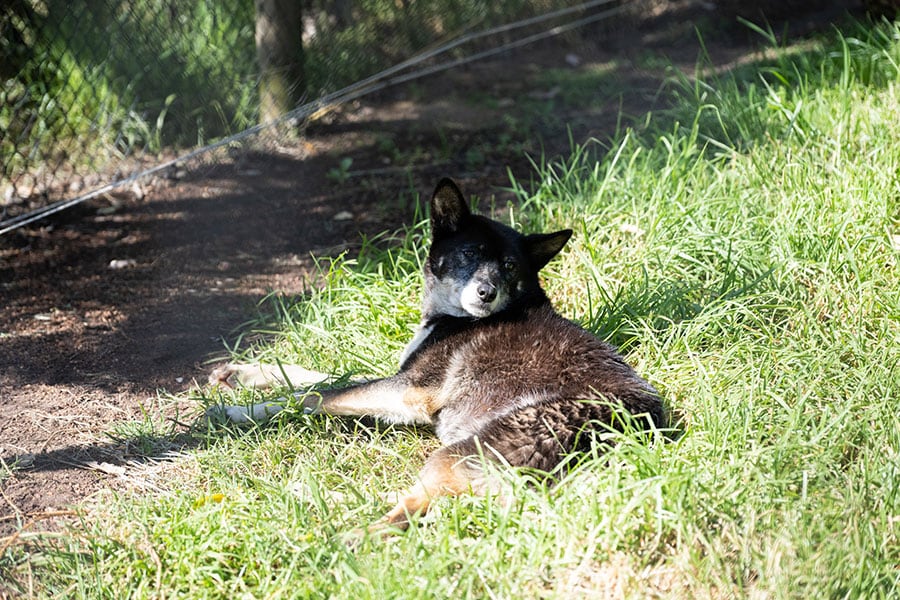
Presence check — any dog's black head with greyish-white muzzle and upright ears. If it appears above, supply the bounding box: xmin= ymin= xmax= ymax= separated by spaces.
xmin=424 ymin=179 xmax=572 ymax=318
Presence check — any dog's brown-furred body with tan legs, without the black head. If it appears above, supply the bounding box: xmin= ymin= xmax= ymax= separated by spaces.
xmin=308 ymin=304 xmax=665 ymax=530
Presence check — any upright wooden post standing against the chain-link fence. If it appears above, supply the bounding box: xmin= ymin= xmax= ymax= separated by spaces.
xmin=256 ymin=0 xmax=305 ymax=123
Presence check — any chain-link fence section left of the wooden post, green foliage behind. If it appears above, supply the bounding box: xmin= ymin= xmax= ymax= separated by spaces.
xmin=0 ymin=0 xmax=256 ymax=217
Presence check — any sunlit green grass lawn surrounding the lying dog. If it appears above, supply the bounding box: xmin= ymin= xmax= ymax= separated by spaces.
xmin=7 ymin=17 xmax=900 ymax=598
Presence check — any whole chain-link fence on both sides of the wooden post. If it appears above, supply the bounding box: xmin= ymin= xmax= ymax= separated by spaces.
xmin=0 ymin=0 xmax=652 ymax=233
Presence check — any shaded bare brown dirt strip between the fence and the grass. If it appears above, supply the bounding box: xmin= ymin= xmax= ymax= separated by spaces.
xmin=0 ymin=2 xmax=854 ymax=545
